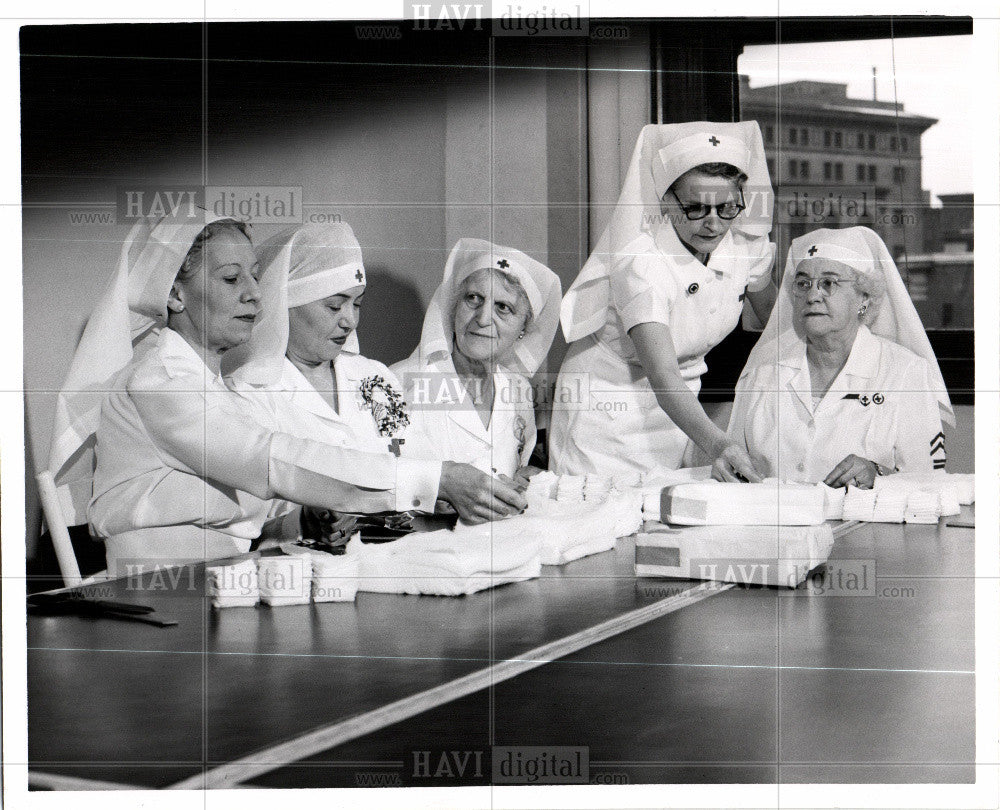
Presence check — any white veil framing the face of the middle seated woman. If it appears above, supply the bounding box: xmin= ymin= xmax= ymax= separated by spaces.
xmin=414 ymin=238 xmax=562 ymax=377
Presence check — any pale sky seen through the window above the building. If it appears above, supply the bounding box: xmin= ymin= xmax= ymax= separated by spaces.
xmin=739 ymin=37 xmax=977 ymax=202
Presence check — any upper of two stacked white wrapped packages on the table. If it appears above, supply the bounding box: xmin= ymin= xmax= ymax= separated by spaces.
xmin=644 ymin=481 xmax=824 ymax=526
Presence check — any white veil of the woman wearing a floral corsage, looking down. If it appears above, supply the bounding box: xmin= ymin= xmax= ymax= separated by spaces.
xmin=224 ymin=222 xmax=367 ymax=387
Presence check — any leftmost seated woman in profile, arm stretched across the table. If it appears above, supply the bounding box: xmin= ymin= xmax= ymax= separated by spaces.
xmin=52 ymin=213 xmax=472 ymax=572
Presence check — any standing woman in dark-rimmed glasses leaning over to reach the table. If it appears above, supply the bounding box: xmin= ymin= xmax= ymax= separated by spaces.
xmin=549 ymin=121 xmax=775 ymax=484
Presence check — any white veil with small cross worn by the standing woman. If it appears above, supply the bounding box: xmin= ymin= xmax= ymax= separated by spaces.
xmin=562 ymin=121 xmax=774 ymax=343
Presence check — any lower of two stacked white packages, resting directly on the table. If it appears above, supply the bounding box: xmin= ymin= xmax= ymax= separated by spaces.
xmin=635 ymin=523 xmax=833 ymax=588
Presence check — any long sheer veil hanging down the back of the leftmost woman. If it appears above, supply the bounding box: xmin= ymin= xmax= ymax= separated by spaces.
xmin=48 ymin=211 xmax=228 ymax=525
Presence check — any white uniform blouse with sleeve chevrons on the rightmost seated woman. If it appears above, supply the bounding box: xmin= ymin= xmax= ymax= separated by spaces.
xmin=729 ymin=326 xmax=945 ymax=482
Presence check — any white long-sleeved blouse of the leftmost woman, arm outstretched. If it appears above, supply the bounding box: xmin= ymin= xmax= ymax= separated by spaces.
xmin=88 ymin=329 xmax=440 ymax=570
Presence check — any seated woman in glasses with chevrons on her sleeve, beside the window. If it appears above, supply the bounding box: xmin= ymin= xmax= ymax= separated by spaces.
xmin=729 ymin=227 xmax=954 ymax=487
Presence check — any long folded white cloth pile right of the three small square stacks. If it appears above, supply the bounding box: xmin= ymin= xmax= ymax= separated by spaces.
xmin=358 ymin=518 xmax=541 ymax=596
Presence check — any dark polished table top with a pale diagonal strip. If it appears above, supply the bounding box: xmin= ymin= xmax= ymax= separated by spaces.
xmin=28 ymin=508 xmax=975 ymax=787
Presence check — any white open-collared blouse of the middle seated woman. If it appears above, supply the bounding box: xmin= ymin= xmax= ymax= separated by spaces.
xmin=392 ymin=353 xmax=536 ymax=476
